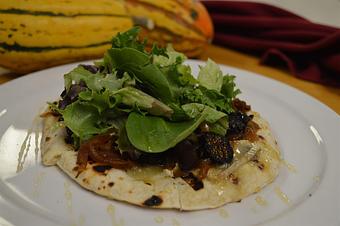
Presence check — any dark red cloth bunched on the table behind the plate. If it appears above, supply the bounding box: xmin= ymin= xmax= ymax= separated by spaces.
xmin=203 ymin=1 xmax=340 ymax=87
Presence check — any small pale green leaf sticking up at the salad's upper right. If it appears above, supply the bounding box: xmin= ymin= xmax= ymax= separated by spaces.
xmin=198 ymin=59 xmax=223 ymax=92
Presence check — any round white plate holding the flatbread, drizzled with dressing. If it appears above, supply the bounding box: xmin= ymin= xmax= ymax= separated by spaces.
xmin=0 ymin=61 xmax=340 ymax=226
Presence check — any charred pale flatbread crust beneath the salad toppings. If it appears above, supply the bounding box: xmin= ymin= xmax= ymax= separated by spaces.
xmin=42 ymin=112 xmax=280 ymax=210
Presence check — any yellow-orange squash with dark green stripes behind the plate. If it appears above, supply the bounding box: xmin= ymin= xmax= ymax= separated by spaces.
xmin=0 ymin=0 xmax=213 ymax=73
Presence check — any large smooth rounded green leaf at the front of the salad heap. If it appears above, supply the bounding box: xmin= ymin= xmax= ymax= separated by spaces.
xmin=126 ymin=112 xmax=207 ymax=153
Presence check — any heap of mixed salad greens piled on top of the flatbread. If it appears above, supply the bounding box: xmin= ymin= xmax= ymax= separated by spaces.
xmin=51 ymin=27 xmax=240 ymax=153
